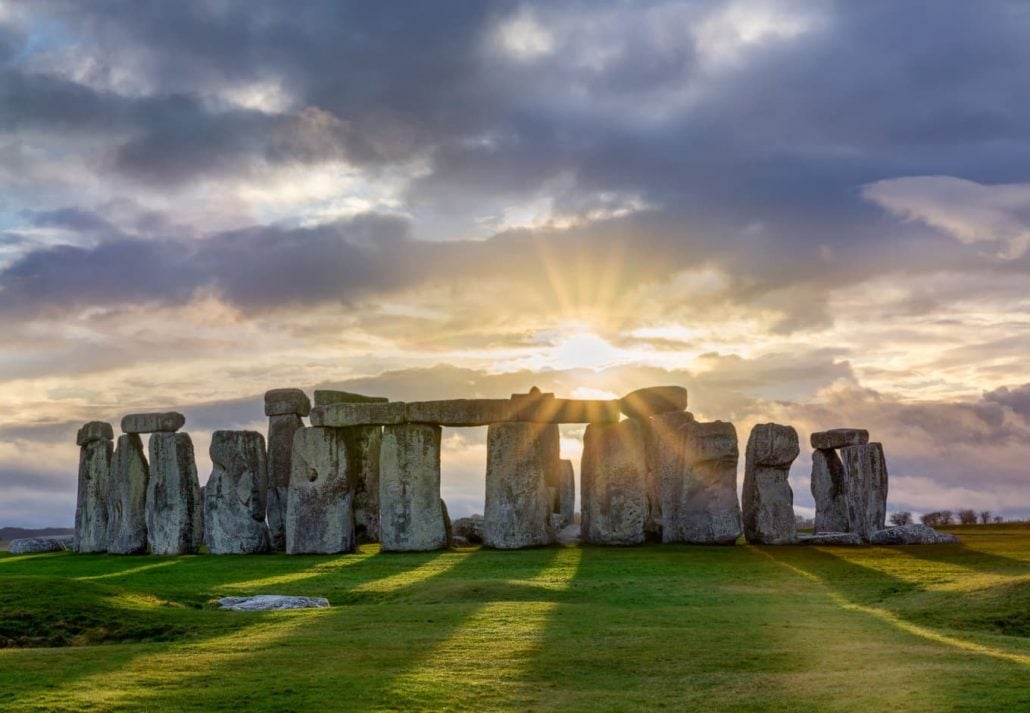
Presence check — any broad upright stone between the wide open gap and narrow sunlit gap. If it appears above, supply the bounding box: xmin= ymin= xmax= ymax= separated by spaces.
xmin=483 ymin=422 xmax=560 ymax=549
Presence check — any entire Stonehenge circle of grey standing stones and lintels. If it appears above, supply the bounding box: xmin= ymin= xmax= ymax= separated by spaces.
xmin=68 ymin=385 xmax=910 ymax=554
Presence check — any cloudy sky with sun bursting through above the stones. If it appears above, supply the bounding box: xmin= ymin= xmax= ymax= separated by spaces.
xmin=0 ymin=0 xmax=1030 ymax=527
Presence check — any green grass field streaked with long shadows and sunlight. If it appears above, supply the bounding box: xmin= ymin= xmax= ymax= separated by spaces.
xmin=0 ymin=525 xmax=1030 ymax=712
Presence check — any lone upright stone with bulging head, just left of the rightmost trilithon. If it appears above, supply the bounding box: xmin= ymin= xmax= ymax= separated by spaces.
xmin=741 ymin=423 xmax=799 ymax=545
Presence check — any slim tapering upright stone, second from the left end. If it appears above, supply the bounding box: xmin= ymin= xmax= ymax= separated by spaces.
xmin=107 ymin=434 xmax=150 ymax=554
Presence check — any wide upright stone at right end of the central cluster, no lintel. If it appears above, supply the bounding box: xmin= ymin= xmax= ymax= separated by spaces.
xmin=652 ymin=414 xmax=742 ymax=545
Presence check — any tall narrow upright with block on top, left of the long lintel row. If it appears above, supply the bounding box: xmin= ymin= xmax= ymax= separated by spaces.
xmin=265 ymin=388 xmax=311 ymax=552
